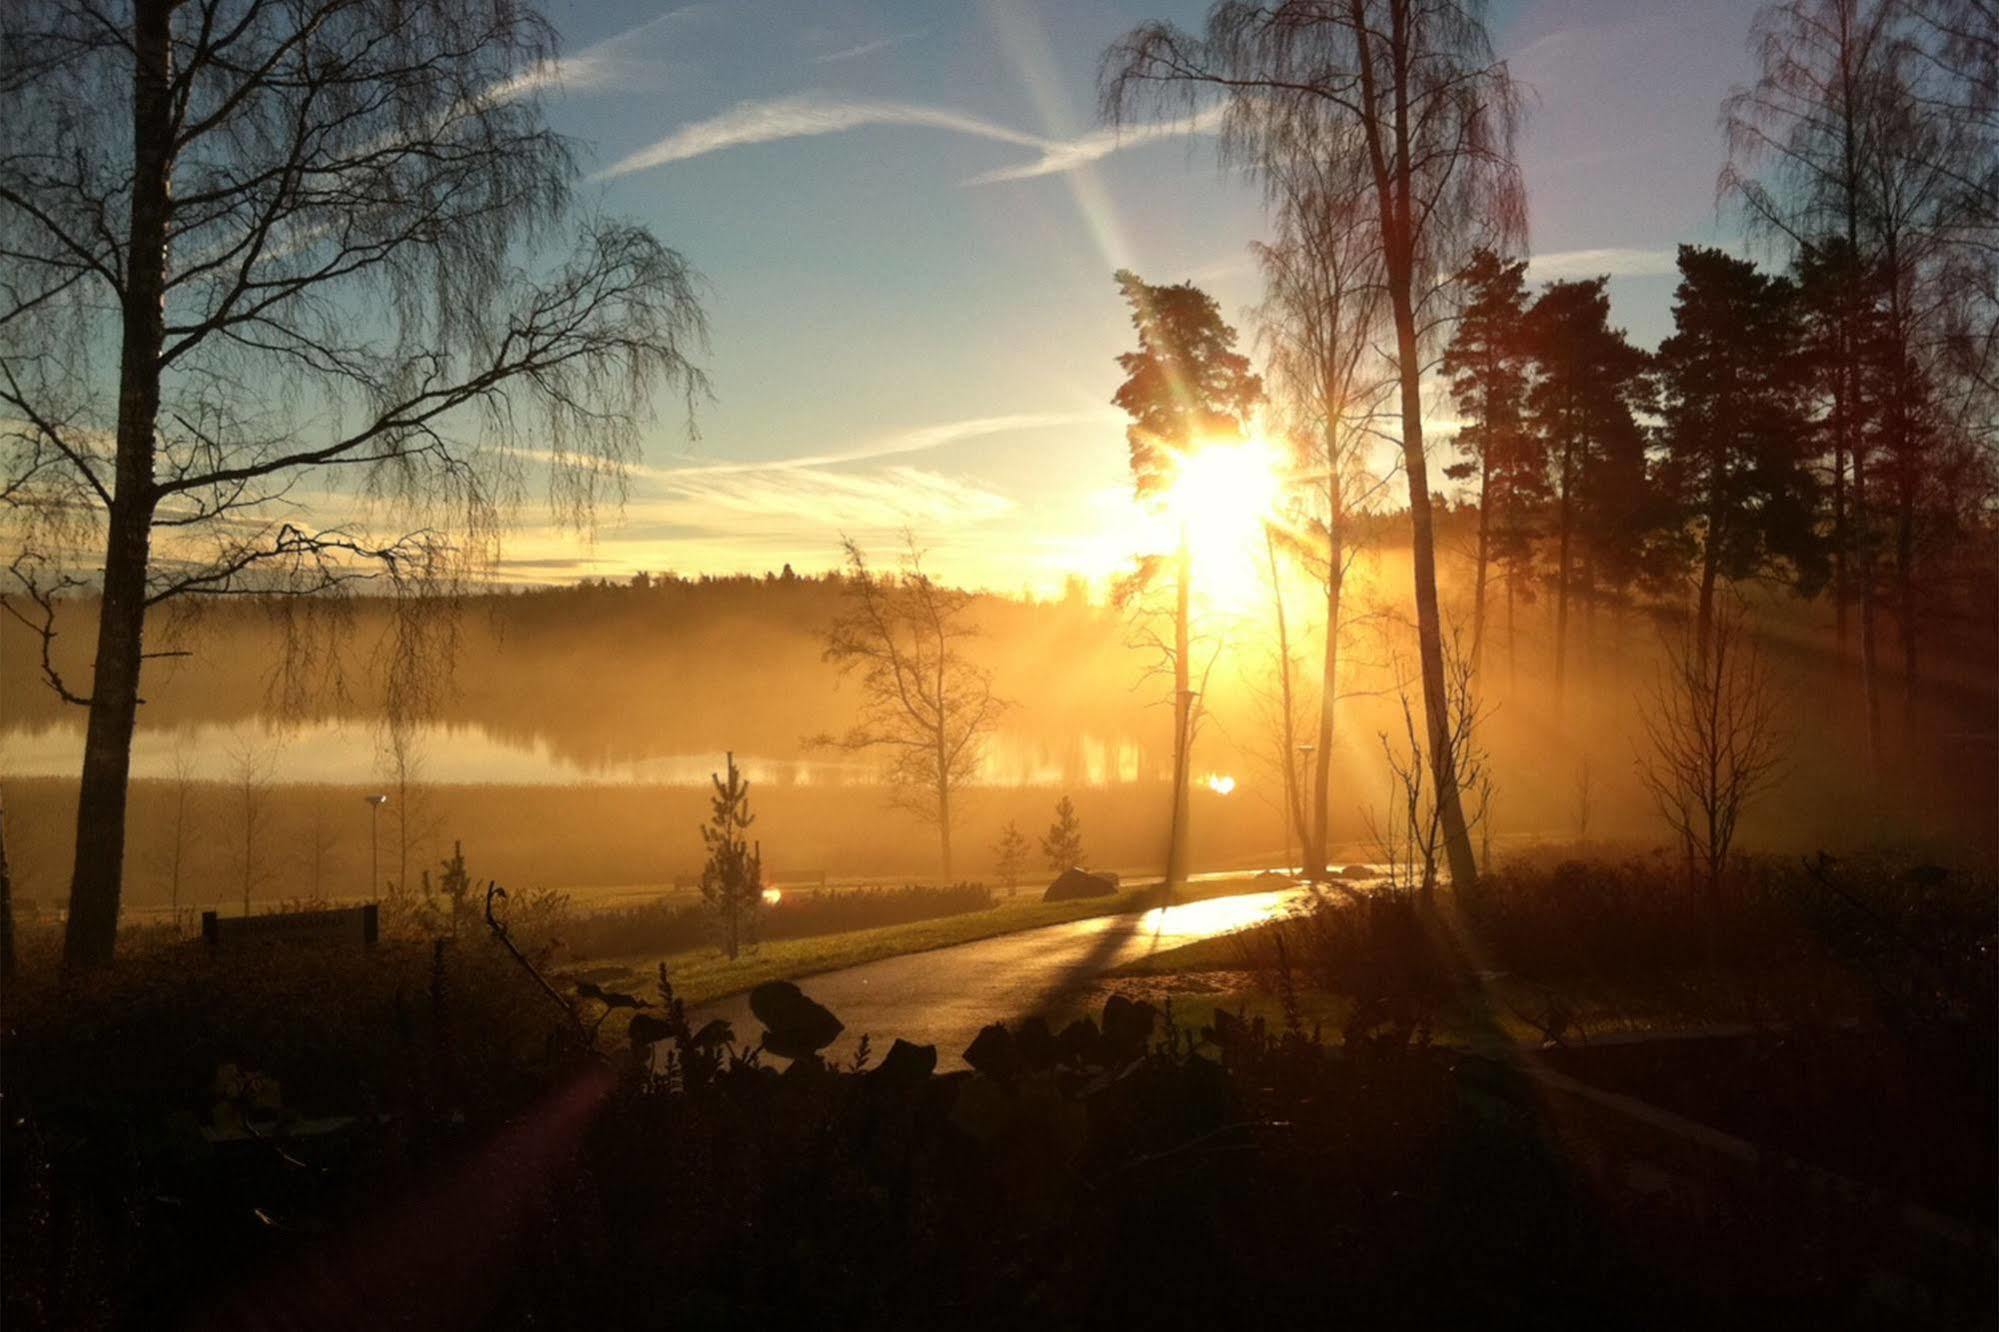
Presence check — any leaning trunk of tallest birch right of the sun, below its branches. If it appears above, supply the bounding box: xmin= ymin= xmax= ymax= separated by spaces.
xmin=1389 ymin=286 xmax=1479 ymax=892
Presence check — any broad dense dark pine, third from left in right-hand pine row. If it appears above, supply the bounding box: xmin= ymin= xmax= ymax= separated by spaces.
xmin=1657 ymin=246 xmax=1823 ymax=644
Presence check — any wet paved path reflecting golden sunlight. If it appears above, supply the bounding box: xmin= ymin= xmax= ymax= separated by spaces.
xmin=696 ymin=888 xmax=1311 ymax=1070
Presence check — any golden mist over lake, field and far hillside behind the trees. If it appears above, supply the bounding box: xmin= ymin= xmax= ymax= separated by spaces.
xmin=11 ymin=512 xmax=1995 ymax=912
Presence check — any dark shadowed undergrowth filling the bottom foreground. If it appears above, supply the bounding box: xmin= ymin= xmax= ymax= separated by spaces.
xmin=0 ymin=926 xmax=1991 ymax=1328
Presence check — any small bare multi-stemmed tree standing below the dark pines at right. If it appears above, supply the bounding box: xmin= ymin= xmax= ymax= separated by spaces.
xmin=1637 ymin=604 xmax=1783 ymax=902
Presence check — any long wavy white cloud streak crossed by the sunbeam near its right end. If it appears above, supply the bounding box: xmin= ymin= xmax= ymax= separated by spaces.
xmin=596 ymin=92 xmax=1219 ymax=184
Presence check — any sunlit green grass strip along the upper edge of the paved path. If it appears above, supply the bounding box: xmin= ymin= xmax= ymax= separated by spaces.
xmin=562 ymin=874 xmax=1277 ymax=1004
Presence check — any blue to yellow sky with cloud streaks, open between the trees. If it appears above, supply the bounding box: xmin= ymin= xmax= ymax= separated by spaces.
xmin=510 ymin=0 xmax=1755 ymax=590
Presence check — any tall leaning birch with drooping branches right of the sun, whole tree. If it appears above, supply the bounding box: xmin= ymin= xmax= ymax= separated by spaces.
xmin=1101 ymin=0 xmax=1525 ymax=884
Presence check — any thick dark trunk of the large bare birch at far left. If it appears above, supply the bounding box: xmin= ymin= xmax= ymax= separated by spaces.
xmin=62 ymin=0 xmax=172 ymax=970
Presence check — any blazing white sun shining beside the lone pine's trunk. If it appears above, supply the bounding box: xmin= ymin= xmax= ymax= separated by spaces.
xmin=1165 ymin=438 xmax=1283 ymax=610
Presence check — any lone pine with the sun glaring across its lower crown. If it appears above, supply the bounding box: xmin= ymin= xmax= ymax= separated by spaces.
xmin=1111 ymin=270 xmax=1263 ymax=884
